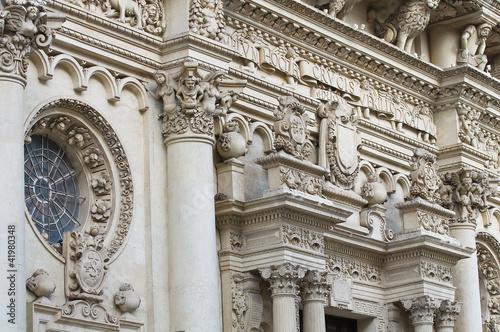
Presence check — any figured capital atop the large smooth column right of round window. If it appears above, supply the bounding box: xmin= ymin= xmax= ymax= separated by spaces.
xmin=154 ymin=62 xmax=237 ymax=139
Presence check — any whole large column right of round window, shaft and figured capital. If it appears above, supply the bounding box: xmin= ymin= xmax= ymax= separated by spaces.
xmin=155 ymin=62 xmax=229 ymax=332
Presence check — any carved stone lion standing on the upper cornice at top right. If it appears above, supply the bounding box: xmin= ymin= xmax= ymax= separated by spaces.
xmin=376 ymin=0 xmax=439 ymax=52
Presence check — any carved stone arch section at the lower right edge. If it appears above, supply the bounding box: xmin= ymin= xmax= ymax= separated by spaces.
xmin=476 ymin=232 xmax=500 ymax=331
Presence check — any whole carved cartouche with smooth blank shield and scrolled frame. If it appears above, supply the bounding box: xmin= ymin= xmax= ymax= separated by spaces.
xmin=317 ymin=99 xmax=361 ymax=189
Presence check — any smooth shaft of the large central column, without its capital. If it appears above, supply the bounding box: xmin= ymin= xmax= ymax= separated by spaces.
xmin=165 ymin=134 xmax=220 ymax=332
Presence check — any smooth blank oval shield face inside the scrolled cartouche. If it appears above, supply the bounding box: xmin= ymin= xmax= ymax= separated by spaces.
xmin=336 ymin=124 xmax=358 ymax=174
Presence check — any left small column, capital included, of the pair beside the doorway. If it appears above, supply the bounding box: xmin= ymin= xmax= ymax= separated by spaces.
xmin=261 ymin=263 xmax=305 ymax=332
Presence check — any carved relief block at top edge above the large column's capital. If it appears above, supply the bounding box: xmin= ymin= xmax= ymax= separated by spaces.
xmin=189 ymin=0 xmax=226 ymax=41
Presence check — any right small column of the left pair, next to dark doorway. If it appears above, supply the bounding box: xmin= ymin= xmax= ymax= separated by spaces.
xmin=301 ymin=271 xmax=328 ymax=332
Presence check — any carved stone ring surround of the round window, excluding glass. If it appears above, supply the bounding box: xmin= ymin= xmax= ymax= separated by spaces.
xmin=25 ymin=98 xmax=134 ymax=263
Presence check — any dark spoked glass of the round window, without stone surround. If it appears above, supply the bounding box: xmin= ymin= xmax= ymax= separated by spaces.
xmin=24 ymin=135 xmax=83 ymax=243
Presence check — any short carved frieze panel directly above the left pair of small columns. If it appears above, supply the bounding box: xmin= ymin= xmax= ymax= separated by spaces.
xmin=281 ymin=224 xmax=325 ymax=253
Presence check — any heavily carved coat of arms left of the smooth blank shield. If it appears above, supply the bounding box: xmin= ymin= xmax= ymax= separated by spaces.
xmin=273 ymin=96 xmax=312 ymax=159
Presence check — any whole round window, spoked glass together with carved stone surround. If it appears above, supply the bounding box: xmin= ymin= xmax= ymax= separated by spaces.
xmin=24 ymin=99 xmax=133 ymax=260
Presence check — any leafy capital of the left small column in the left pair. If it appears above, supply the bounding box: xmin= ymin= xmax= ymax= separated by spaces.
xmin=260 ymin=263 xmax=306 ymax=297
